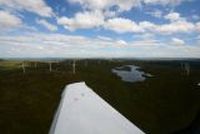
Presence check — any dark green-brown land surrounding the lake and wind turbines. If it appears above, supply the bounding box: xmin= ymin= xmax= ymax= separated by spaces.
xmin=0 ymin=59 xmax=200 ymax=134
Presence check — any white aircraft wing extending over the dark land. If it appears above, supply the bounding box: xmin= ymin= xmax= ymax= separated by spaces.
xmin=49 ymin=82 xmax=144 ymax=134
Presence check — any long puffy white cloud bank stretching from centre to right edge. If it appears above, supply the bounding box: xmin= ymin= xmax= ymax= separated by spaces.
xmin=57 ymin=12 xmax=199 ymax=34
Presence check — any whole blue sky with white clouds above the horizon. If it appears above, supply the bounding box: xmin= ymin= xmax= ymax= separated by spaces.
xmin=0 ymin=0 xmax=200 ymax=58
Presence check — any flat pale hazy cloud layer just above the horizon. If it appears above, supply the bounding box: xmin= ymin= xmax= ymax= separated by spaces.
xmin=0 ymin=33 xmax=200 ymax=58
